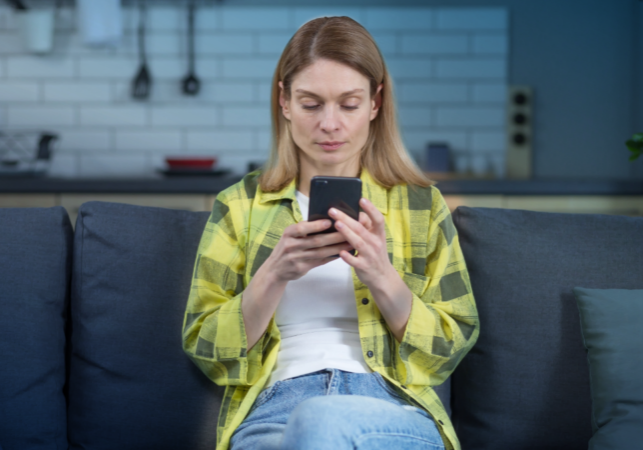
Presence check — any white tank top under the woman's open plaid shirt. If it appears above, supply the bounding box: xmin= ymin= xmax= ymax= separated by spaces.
xmin=266 ymin=191 xmax=372 ymax=387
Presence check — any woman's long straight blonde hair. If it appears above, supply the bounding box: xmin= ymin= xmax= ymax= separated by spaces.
xmin=258 ymin=16 xmax=435 ymax=192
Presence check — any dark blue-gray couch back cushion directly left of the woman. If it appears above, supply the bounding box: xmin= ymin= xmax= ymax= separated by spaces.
xmin=68 ymin=202 xmax=223 ymax=450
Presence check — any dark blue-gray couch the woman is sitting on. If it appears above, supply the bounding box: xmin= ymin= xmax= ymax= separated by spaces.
xmin=0 ymin=202 xmax=643 ymax=450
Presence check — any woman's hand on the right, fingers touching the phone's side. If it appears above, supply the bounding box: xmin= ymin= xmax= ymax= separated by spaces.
xmin=329 ymin=198 xmax=395 ymax=289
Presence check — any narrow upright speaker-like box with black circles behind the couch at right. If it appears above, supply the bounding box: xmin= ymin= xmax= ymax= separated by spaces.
xmin=507 ymin=86 xmax=534 ymax=179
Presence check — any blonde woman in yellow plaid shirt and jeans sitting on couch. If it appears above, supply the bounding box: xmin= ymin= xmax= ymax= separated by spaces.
xmin=183 ymin=17 xmax=478 ymax=450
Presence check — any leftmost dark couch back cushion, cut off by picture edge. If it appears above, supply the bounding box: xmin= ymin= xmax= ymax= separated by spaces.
xmin=0 ymin=207 xmax=72 ymax=450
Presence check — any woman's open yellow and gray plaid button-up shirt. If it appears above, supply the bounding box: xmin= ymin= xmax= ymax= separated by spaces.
xmin=183 ymin=169 xmax=479 ymax=450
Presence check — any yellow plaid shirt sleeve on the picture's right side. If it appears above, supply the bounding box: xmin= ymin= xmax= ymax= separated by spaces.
xmin=393 ymin=186 xmax=480 ymax=386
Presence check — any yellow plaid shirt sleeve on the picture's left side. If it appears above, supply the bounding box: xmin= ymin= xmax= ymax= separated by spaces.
xmin=183 ymin=193 xmax=272 ymax=386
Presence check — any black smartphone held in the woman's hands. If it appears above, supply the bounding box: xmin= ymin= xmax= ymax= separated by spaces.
xmin=308 ymin=176 xmax=362 ymax=255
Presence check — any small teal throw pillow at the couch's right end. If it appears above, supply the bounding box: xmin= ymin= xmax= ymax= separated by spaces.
xmin=574 ymin=288 xmax=643 ymax=450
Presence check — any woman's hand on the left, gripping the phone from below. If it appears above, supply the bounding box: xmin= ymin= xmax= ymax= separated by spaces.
xmin=264 ymin=219 xmax=353 ymax=282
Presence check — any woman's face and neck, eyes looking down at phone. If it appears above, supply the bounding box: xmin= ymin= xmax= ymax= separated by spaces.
xmin=279 ymin=59 xmax=382 ymax=176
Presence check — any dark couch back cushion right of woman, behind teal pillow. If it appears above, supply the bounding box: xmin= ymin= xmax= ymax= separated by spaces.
xmin=451 ymin=207 xmax=643 ymax=450
